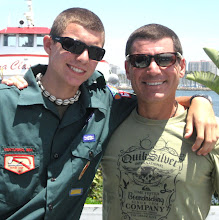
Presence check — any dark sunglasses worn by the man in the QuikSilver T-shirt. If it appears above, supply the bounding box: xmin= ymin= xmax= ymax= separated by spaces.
xmin=126 ymin=52 xmax=182 ymax=68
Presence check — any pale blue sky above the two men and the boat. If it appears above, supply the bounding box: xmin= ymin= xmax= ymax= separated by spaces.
xmin=0 ymin=0 xmax=219 ymax=68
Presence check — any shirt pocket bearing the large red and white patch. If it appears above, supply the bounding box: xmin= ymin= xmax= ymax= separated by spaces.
xmin=0 ymin=146 xmax=40 ymax=206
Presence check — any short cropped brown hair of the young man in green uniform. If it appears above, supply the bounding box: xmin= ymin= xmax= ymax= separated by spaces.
xmin=50 ymin=8 xmax=105 ymax=44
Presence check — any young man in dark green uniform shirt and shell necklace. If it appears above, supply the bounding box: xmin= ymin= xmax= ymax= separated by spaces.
xmin=0 ymin=8 xmax=215 ymax=219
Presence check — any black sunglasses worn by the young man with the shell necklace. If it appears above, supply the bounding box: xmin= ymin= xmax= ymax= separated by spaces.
xmin=51 ymin=36 xmax=105 ymax=61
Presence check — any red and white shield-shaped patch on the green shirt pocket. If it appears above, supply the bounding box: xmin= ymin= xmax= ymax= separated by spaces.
xmin=4 ymin=154 xmax=35 ymax=174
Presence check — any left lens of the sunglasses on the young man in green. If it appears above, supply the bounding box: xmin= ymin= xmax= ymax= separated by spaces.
xmin=62 ymin=38 xmax=86 ymax=54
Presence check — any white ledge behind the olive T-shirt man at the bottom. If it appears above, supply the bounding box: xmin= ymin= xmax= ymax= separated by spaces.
xmin=80 ymin=205 xmax=219 ymax=220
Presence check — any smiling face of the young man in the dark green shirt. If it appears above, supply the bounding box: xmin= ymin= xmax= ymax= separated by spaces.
xmin=44 ymin=23 xmax=104 ymax=91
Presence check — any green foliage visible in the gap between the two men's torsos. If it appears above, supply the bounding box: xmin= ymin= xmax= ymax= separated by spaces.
xmin=85 ymin=167 xmax=103 ymax=204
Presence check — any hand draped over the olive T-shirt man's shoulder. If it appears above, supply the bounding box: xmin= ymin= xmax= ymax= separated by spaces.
xmin=184 ymin=97 xmax=219 ymax=155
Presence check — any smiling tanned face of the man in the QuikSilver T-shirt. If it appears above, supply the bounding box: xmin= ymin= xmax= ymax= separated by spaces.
xmin=125 ymin=38 xmax=185 ymax=104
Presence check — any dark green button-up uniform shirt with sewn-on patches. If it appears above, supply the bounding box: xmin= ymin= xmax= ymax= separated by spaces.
xmin=0 ymin=65 xmax=136 ymax=220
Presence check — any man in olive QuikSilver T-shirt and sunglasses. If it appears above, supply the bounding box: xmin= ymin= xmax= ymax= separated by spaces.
xmin=102 ymin=24 xmax=219 ymax=220
